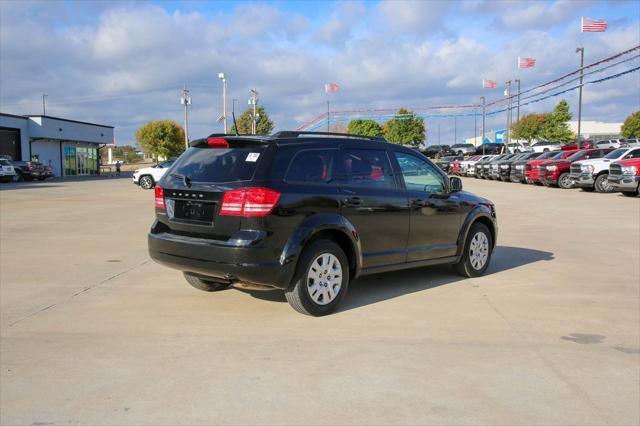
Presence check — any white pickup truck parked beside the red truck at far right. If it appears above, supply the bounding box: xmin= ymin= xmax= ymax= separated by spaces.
xmin=569 ymin=148 xmax=640 ymax=192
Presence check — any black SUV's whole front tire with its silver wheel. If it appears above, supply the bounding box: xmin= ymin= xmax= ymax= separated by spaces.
xmin=454 ymin=222 xmax=493 ymax=278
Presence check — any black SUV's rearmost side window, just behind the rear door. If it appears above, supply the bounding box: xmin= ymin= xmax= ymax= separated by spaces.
xmin=285 ymin=149 xmax=338 ymax=183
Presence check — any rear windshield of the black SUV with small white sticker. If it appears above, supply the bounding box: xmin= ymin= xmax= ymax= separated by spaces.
xmin=171 ymin=146 xmax=266 ymax=183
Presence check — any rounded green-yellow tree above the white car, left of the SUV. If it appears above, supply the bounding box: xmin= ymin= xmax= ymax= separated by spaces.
xmin=136 ymin=120 xmax=185 ymax=158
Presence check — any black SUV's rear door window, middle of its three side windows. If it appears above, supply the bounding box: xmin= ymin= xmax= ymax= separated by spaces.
xmin=342 ymin=149 xmax=395 ymax=188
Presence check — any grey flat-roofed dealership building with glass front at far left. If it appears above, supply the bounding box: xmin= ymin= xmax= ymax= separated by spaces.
xmin=0 ymin=113 xmax=114 ymax=177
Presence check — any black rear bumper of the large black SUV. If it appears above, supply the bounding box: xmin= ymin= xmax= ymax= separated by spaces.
xmin=147 ymin=228 xmax=295 ymax=289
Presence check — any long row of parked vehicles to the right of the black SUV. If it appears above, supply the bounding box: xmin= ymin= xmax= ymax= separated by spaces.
xmin=450 ymin=144 xmax=640 ymax=196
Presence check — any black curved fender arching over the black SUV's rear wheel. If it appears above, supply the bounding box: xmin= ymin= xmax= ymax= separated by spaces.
xmin=280 ymin=213 xmax=362 ymax=279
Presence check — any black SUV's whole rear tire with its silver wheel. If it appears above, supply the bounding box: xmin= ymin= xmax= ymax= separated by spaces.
xmin=285 ymin=240 xmax=349 ymax=317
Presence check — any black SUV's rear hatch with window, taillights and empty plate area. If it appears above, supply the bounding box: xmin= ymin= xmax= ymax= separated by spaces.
xmin=156 ymin=137 xmax=277 ymax=241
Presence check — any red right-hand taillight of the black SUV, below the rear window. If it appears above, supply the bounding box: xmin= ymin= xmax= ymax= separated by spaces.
xmin=219 ymin=188 xmax=280 ymax=216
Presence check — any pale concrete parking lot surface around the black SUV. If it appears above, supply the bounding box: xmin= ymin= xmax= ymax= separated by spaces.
xmin=0 ymin=179 xmax=640 ymax=425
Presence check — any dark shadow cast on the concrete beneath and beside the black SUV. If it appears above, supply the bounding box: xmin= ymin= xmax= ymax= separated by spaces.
xmin=243 ymin=246 xmax=554 ymax=312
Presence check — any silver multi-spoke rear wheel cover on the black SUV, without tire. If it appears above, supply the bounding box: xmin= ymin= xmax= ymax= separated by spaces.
xmin=307 ymin=253 xmax=342 ymax=305
